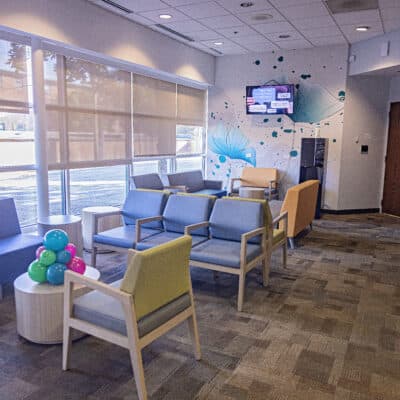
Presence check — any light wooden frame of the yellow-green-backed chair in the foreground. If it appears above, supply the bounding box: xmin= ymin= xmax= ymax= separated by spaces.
xmin=62 ymin=271 xmax=201 ymax=400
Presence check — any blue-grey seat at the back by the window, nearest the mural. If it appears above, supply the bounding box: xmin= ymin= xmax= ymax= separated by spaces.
xmin=167 ymin=171 xmax=226 ymax=197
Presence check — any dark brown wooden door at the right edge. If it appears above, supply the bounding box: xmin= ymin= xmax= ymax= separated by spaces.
xmin=382 ymin=103 xmax=400 ymax=217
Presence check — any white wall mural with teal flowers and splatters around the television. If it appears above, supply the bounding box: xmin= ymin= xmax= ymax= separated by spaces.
xmin=207 ymin=46 xmax=347 ymax=209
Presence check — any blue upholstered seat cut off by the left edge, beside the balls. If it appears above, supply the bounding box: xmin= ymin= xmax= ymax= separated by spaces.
xmin=0 ymin=198 xmax=42 ymax=299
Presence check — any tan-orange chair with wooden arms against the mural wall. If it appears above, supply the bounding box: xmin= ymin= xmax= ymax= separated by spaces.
xmin=230 ymin=167 xmax=279 ymax=200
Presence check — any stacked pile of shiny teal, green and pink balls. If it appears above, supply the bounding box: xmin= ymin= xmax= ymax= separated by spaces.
xmin=28 ymin=229 xmax=86 ymax=285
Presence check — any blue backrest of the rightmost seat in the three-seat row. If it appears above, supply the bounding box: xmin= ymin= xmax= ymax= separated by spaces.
xmin=210 ymin=199 xmax=265 ymax=243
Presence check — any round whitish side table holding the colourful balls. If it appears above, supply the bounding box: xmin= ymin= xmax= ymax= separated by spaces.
xmin=14 ymin=266 xmax=100 ymax=344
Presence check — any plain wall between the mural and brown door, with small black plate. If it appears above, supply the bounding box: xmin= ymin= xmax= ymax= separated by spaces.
xmin=338 ymin=76 xmax=390 ymax=210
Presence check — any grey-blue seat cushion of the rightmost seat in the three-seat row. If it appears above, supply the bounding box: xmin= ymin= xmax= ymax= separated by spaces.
xmin=190 ymin=239 xmax=261 ymax=268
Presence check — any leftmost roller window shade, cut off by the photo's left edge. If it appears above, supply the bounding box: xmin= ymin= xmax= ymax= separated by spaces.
xmin=0 ymin=39 xmax=29 ymax=114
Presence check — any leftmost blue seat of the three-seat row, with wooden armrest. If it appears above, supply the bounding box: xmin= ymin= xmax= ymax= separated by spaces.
xmin=91 ymin=189 xmax=168 ymax=267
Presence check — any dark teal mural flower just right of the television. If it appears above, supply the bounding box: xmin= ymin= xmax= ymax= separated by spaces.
xmin=290 ymin=82 xmax=343 ymax=123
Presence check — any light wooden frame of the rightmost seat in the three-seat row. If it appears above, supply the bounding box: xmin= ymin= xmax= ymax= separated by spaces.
xmin=185 ymin=221 xmax=269 ymax=311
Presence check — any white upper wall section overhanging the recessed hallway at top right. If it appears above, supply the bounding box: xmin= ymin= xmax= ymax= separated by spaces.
xmin=349 ymin=31 xmax=400 ymax=75
